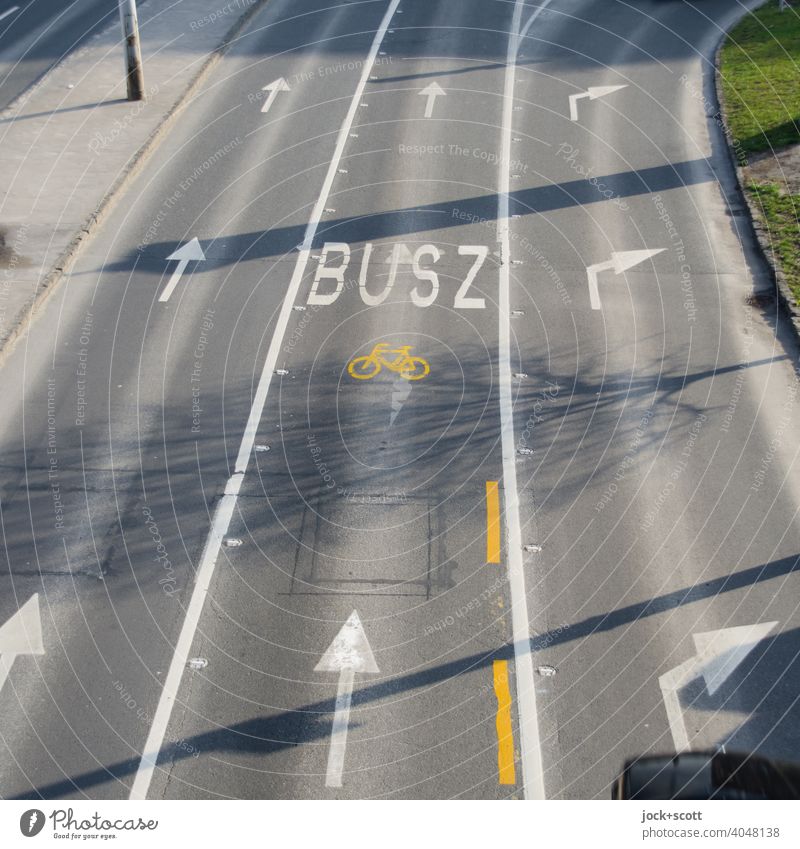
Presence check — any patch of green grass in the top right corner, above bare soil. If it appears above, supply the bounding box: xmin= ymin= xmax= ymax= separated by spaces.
xmin=720 ymin=0 xmax=800 ymax=153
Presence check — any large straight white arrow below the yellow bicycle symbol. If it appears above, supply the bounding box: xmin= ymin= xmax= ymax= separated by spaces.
xmin=314 ymin=610 xmax=380 ymax=787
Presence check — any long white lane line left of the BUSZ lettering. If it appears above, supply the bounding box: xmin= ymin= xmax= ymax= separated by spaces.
xmin=130 ymin=0 xmax=400 ymax=799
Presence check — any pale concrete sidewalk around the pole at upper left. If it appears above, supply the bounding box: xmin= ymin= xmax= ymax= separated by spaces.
xmin=0 ymin=0 xmax=266 ymax=353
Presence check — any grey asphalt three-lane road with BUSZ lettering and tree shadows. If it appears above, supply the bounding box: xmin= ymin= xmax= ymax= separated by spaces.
xmin=0 ymin=0 xmax=800 ymax=798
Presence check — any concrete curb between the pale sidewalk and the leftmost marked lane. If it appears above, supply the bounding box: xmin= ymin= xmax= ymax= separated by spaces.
xmin=0 ymin=0 xmax=269 ymax=365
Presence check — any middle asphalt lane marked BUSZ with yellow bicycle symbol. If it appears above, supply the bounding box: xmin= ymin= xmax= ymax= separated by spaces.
xmin=144 ymin=3 xmax=544 ymax=798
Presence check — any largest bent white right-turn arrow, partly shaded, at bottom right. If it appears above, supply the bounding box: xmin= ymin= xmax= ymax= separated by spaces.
xmin=658 ymin=622 xmax=778 ymax=752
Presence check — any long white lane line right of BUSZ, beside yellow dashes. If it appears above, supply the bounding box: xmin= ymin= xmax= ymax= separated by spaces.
xmin=497 ymin=0 xmax=551 ymax=799
